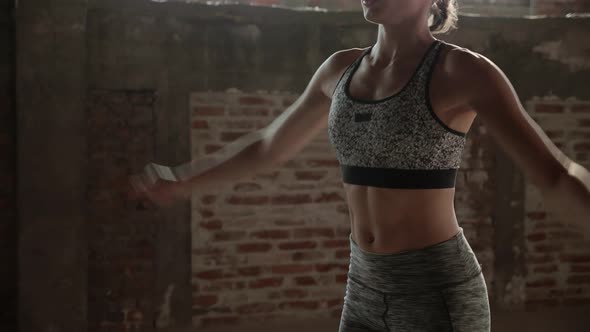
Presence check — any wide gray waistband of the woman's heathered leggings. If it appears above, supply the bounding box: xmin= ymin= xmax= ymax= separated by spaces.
xmin=348 ymin=227 xmax=481 ymax=293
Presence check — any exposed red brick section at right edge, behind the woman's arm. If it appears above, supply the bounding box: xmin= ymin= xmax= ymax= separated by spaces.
xmin=525 ymin=98 xmax=590 ymax=308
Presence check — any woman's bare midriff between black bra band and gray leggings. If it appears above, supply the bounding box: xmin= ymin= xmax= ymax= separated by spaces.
xmin=344 ymin=183 xmax=459 ymax=254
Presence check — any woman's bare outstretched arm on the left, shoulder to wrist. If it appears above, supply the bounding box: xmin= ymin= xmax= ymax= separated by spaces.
xmin=175 ymin=49 xmax=358 ymax=196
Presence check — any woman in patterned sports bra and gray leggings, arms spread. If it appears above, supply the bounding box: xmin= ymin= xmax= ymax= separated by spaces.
xmin=132 ymin=0 xmax=590 ymax=332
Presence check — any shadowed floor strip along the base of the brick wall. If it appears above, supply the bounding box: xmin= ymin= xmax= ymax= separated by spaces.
xmin=197 ymin=307 xmax=590 ymax=332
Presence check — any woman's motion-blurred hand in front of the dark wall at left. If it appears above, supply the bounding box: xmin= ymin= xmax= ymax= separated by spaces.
xmin=129 ymin=165 xmax=190 ymax=207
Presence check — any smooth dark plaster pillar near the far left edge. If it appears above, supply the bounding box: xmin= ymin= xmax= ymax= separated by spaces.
xmin=16 ymin=0 xmax=87 ymax=332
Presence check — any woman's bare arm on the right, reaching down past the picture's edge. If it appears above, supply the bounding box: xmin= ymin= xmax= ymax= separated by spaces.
xmin=458 ymin=52 xmax=590 ymax=237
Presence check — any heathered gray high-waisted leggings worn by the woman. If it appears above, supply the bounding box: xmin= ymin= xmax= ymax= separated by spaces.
xmin=339 ymin=228 xmax=491 ymax=332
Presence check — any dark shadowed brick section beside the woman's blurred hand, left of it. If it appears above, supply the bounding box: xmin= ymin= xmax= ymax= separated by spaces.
xmin=87 ymin=90 xmax=157 ymax=332
